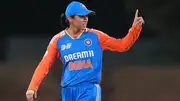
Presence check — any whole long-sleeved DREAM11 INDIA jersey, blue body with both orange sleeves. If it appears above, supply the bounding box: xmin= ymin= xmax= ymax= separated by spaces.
xmin=28 ymin=26 xmax=142 ymax=90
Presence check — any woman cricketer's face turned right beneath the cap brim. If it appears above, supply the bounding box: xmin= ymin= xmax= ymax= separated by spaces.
xmin=68 ymin=15 xmax=88 ymax=30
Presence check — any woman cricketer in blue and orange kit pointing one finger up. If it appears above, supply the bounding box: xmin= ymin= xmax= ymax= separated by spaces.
xmin=26 ymin=1 xmax=144 ymax=101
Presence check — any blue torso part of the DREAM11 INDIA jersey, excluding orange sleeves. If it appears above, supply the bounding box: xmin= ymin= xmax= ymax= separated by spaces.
xmin=57 ymin=30 xmax=103 ymax=86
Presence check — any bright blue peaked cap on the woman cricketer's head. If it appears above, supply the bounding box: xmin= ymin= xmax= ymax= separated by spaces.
xmin=65 ymin=1 xmax=95 ymax=18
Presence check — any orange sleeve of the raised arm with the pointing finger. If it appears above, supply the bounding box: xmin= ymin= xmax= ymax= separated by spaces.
xmin=89 ymin=26 xmax=142 ymax=52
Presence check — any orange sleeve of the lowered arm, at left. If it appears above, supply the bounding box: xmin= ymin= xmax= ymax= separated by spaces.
xmin=28 ymin=32 xmax=65 ymax=91
